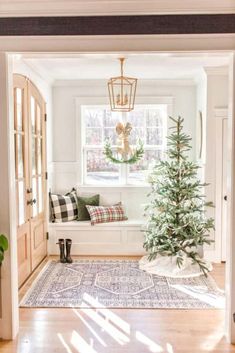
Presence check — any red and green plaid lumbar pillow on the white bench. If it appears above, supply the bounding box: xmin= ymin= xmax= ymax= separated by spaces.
xmin=86 ymin=205 xmax=127 ymax=225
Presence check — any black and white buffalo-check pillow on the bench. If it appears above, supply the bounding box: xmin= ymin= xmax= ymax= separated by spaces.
xmin=50 ymin=190 xmax=78 ymax=223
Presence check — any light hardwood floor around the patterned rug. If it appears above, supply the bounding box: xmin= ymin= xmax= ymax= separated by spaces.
xmin=0 ymin=256 xmax=235 ymax=353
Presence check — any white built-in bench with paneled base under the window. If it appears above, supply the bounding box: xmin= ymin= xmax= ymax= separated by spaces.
xmin=48 ymin=220 xmax=145 ymax=255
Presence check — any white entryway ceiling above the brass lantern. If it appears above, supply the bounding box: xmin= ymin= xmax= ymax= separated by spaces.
xmin=14 ymin=53 xmax=229 ymax=83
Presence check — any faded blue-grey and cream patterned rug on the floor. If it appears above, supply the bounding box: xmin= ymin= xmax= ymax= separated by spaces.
xmin=20 ymin=260 xmax=224 ymax=309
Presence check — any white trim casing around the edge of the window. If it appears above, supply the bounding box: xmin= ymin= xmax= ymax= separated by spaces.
xmin=75 ymin=96 xmax=174 ymax=188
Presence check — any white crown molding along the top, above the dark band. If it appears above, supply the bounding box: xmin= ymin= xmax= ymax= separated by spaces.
xmin=0 ymin=0 xmax=235 ymax=17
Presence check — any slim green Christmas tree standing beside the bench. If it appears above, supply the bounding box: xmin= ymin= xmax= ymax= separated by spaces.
xmin=144 ymin=117 xmax=214 ymax=275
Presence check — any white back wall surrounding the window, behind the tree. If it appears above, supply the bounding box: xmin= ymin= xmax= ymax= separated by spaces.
xmin=51 ymin=80 xmax=196 ymax=192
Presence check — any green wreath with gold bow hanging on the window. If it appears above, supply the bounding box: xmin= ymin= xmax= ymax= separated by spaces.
xmin=104 ymin=122 xmax=144 ymax=164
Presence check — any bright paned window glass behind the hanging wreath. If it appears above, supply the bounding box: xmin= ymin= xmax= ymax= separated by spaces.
xmin=82 ymin=104 xmax=167 ymax=186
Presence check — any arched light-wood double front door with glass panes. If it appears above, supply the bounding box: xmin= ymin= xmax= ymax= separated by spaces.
xmin=14 ymin=75 xmax=47 ymax=286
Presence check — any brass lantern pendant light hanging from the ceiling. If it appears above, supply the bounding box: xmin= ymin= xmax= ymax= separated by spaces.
xmin=108 ymin=58 xmax=137 ymax=112
